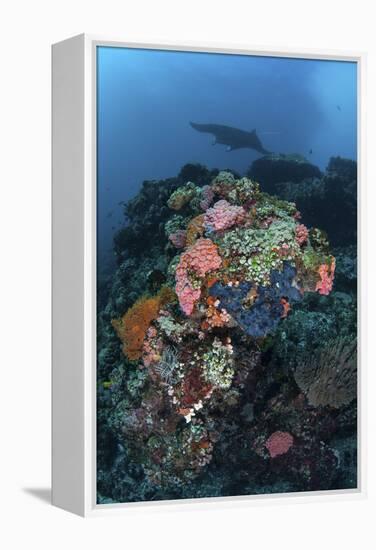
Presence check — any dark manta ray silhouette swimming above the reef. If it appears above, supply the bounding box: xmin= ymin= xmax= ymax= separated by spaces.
xmin=190 ymin=122 xmax=270 ymax=155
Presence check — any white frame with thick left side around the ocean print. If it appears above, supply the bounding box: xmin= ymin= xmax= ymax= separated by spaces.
xmin=52 ymin=34 xmax=366 ymax=516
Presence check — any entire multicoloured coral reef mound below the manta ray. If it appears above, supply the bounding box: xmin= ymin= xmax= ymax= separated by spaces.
xmin=97 ymin=156 xmax=357 ymax=503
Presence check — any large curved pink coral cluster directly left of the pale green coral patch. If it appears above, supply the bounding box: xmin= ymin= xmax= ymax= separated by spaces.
xmin=175 ymin=239 xmax=222 ymax=315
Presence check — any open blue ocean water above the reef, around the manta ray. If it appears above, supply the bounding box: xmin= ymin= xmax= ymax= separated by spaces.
xmin=97 ymin=47 xmax=357 ymax=270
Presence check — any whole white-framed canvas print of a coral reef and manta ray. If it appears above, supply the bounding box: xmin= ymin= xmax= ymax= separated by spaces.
xmin=52 ymin=35 xmax=364 ymax=515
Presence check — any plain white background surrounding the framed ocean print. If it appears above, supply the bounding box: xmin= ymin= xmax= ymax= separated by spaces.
xmin=0 ymin=0 xmax=376 ymax=550
